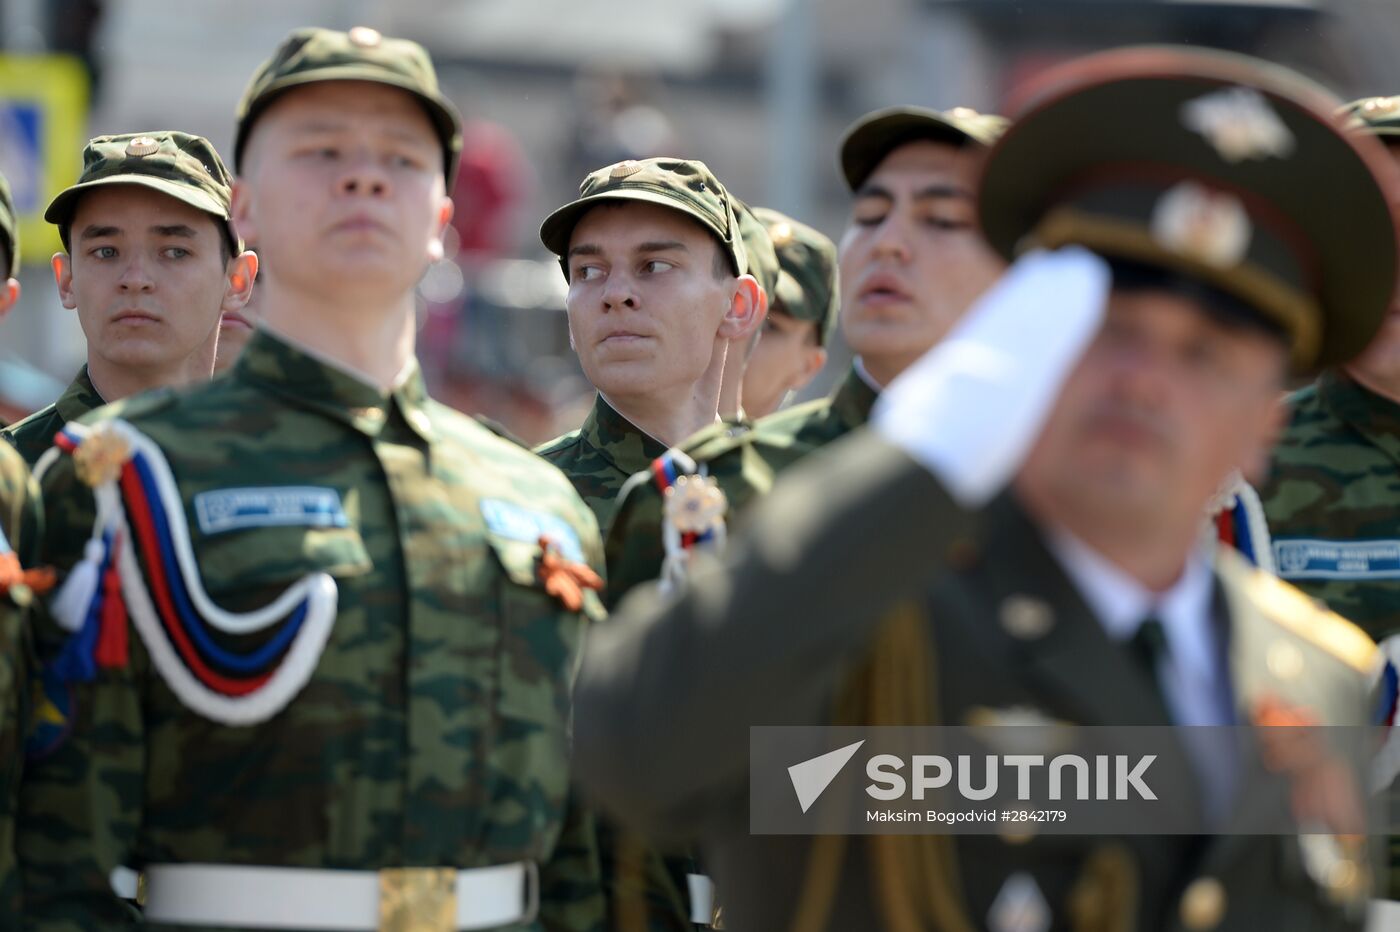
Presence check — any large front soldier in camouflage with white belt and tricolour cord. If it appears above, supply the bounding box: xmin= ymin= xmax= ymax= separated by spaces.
xmin=20 ymin=27 xmax=602 ymax=931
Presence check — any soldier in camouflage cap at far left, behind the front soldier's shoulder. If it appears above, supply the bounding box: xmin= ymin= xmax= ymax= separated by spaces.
xmin=4 ymin=132 xmax=258 ymax=465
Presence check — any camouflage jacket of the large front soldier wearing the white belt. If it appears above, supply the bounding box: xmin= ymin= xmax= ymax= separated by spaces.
xmin=18 ymin=332 xmax=602 ymax=931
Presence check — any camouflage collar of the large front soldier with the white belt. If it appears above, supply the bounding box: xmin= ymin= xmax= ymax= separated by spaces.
xmin=234 ymin=327 xmax=434 ymax=442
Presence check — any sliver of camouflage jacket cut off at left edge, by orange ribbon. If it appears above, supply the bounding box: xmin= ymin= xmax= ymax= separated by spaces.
xmin=0 ymin=444 xmax=41 ymax=925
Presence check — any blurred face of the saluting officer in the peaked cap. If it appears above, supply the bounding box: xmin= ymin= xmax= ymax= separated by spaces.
xmin=1018 ymin=290 xmax=1287 ymax=535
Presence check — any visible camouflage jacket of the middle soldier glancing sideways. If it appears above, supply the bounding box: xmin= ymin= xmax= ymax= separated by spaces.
xmin=535 ymin=395 xmax=666 ymax=532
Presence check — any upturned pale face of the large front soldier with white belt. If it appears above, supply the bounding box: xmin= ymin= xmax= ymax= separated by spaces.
xmin=234 ymin=81 xmax=452 ymax=306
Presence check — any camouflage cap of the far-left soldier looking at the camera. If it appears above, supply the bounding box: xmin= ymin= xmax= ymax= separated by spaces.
xmin=43 ymin=130 xmax=244 ymax=255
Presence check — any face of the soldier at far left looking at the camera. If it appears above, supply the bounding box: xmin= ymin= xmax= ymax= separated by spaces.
xmin=55 ymin=185 xmax=241 ymax=368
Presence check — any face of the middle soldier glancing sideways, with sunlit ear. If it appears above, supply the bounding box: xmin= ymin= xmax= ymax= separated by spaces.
xmin=566 ymin=203 xmax=741 ymax=397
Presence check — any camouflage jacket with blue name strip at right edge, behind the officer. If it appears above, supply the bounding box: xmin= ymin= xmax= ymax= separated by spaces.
xmin=1259 ymin=371 xmax=1400 ymax=641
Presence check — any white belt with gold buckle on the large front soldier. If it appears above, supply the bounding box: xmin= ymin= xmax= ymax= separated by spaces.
xmin=144 ymin=861 xmax=539 ymax=932
